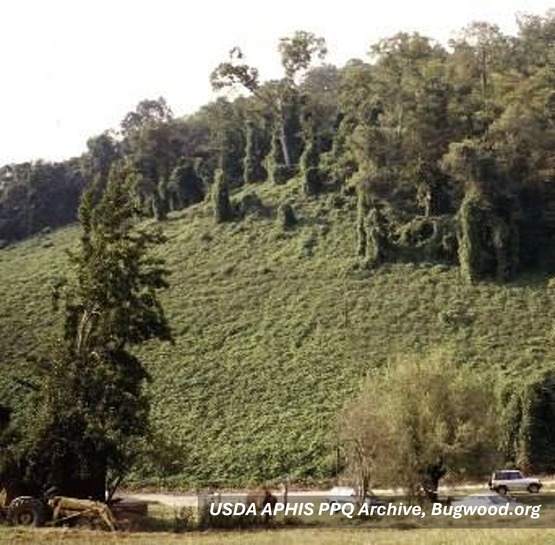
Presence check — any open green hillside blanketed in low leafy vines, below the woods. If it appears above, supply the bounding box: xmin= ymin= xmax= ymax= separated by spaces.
xmin=0 ymin=183 xmax=555 ymax=486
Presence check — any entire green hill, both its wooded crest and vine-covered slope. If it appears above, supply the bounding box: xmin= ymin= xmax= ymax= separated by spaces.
xmin=0 ymin=13 xmax=555 ymax=487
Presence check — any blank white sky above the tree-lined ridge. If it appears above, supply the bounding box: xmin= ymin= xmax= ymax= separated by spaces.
xmin=0 ymin=0 xmax=554 ymax=165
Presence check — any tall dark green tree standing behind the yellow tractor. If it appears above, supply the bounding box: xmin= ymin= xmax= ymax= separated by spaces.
xmin=13 ymin=166 xmax=172 ymax=499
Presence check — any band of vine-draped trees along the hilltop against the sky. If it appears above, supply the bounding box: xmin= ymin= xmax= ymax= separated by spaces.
xmin=0 ymin=12 xmax=555 ymax=279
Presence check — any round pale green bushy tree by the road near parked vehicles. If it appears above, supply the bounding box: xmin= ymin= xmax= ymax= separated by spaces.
xmin=339 ymin=352 xmax=498 ymax=498
